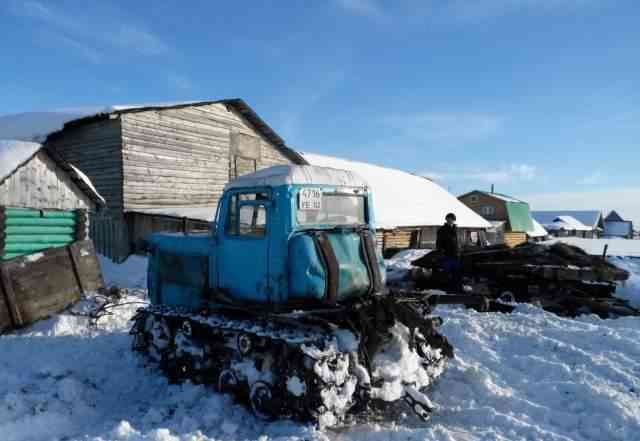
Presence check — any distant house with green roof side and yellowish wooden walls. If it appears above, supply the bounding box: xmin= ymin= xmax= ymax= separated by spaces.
xmin=458 ymin=190 xmax=547 ymax=247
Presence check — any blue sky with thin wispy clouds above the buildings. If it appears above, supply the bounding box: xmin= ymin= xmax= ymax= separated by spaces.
xmin=0 ymin=0 xmax=640 ymax=223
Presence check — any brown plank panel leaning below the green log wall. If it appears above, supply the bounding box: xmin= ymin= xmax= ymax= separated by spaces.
xmin=0 ymin=241 xmax=104 ymax=333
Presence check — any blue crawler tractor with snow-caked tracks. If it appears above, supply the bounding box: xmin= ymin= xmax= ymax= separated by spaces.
xmin=131 ymin=166 xmax=453 ymax=426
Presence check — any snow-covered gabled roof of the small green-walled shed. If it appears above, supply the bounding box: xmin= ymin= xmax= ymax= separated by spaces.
xmin=0 ymin=140 xmax=105 ymax=205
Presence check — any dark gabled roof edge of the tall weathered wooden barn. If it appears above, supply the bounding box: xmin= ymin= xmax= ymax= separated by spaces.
xmin=45 ymin=98 xmax=306 ymax=164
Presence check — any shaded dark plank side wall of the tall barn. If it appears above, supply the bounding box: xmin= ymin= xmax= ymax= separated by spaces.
xmin=46 ymin=118 xmax=122 ymax=212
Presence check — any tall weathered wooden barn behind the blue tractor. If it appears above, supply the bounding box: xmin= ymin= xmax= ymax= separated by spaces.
xmin=45 ymin=99 xmax=306 ymax=261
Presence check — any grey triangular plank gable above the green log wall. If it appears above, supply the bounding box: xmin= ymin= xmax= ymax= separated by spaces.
xmin=0 ymin=150 xmax=95 ymax=211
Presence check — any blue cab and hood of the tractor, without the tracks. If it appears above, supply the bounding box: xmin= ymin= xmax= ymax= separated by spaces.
xmin=149 ymin=165 xmax=384 ymax=310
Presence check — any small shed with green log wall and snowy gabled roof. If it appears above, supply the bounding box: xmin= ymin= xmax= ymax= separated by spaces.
xmin=0 ymin=141 xmax=104 ymax=260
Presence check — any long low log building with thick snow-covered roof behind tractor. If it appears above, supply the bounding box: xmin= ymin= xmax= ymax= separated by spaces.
xmin=302 ymin=153 xmax=491 ymax=256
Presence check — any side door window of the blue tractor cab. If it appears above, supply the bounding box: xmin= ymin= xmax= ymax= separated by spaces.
xmin=225 ymin=193 xmax=269 ymax=238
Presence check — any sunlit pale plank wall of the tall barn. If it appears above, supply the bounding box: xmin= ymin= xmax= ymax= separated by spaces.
xmin=121 ymin=104 xmax=290 ymax=211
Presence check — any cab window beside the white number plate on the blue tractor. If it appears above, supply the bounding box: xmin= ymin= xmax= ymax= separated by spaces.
xmin=296 ymin=188 xmax=367 ymax=226
